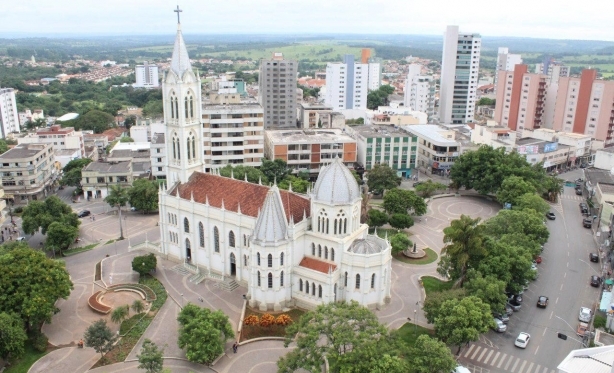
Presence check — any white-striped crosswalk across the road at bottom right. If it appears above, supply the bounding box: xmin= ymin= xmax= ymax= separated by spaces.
xmin=462 ymin=344 xmax=556 ymax=373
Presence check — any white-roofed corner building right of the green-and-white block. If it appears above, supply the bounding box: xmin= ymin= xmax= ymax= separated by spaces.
xmin=402 ymin=124 xmax=461 ymax=175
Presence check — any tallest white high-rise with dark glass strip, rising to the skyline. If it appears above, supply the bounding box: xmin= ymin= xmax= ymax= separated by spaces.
xmin=439 ymin=26 xmax=482 ymax=124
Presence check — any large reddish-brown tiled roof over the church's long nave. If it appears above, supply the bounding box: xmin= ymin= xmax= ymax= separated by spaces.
xmin=169 ymin=172 xmax=310 ymax=222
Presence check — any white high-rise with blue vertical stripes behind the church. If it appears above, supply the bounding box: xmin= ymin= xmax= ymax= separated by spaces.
xmin=324 ymin=54 xmax=380 ymax=110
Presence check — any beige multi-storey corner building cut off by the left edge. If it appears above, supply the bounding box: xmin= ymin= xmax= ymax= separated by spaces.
xmin=0 ymin=144 xmax=57 ymax=203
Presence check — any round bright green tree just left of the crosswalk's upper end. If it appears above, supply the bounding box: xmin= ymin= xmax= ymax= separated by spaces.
xmin=435 ymin=296 xmax=493 ymax=354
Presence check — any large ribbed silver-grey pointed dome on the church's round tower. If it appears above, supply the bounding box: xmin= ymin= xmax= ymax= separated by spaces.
xmin=313 ymin=158 xmax=360 ymax=204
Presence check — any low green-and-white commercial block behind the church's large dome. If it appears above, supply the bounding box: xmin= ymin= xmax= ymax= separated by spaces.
xmin=347 ymin=125 xmax=418 ymax=177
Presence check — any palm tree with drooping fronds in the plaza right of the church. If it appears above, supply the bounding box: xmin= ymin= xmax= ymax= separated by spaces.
xmin=441 ymin=215 xmax=486 ymax=285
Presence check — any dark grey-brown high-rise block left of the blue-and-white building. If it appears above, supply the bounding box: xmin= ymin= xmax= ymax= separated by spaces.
xmin=258 ymin=53 xmax=298 ymax=129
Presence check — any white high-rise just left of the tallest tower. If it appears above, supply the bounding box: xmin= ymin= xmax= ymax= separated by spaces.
xmin=403 ymin=64 xmax=435 ymax=121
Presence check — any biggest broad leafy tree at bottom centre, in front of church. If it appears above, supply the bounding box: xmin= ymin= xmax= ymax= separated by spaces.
xmin=277 ymin=301 xmax=390 ymax=373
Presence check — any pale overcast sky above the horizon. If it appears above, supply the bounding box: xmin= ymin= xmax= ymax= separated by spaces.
xmin=0 ymin=0 xmax=614 ymax=41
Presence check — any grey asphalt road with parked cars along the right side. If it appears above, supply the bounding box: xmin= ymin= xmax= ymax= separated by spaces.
xmin=460 ymin=171 xmax=600 ymax=373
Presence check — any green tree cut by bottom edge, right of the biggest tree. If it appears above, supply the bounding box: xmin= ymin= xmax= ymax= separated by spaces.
xmin=408 ymin=334 xmax=457 ymax=373
